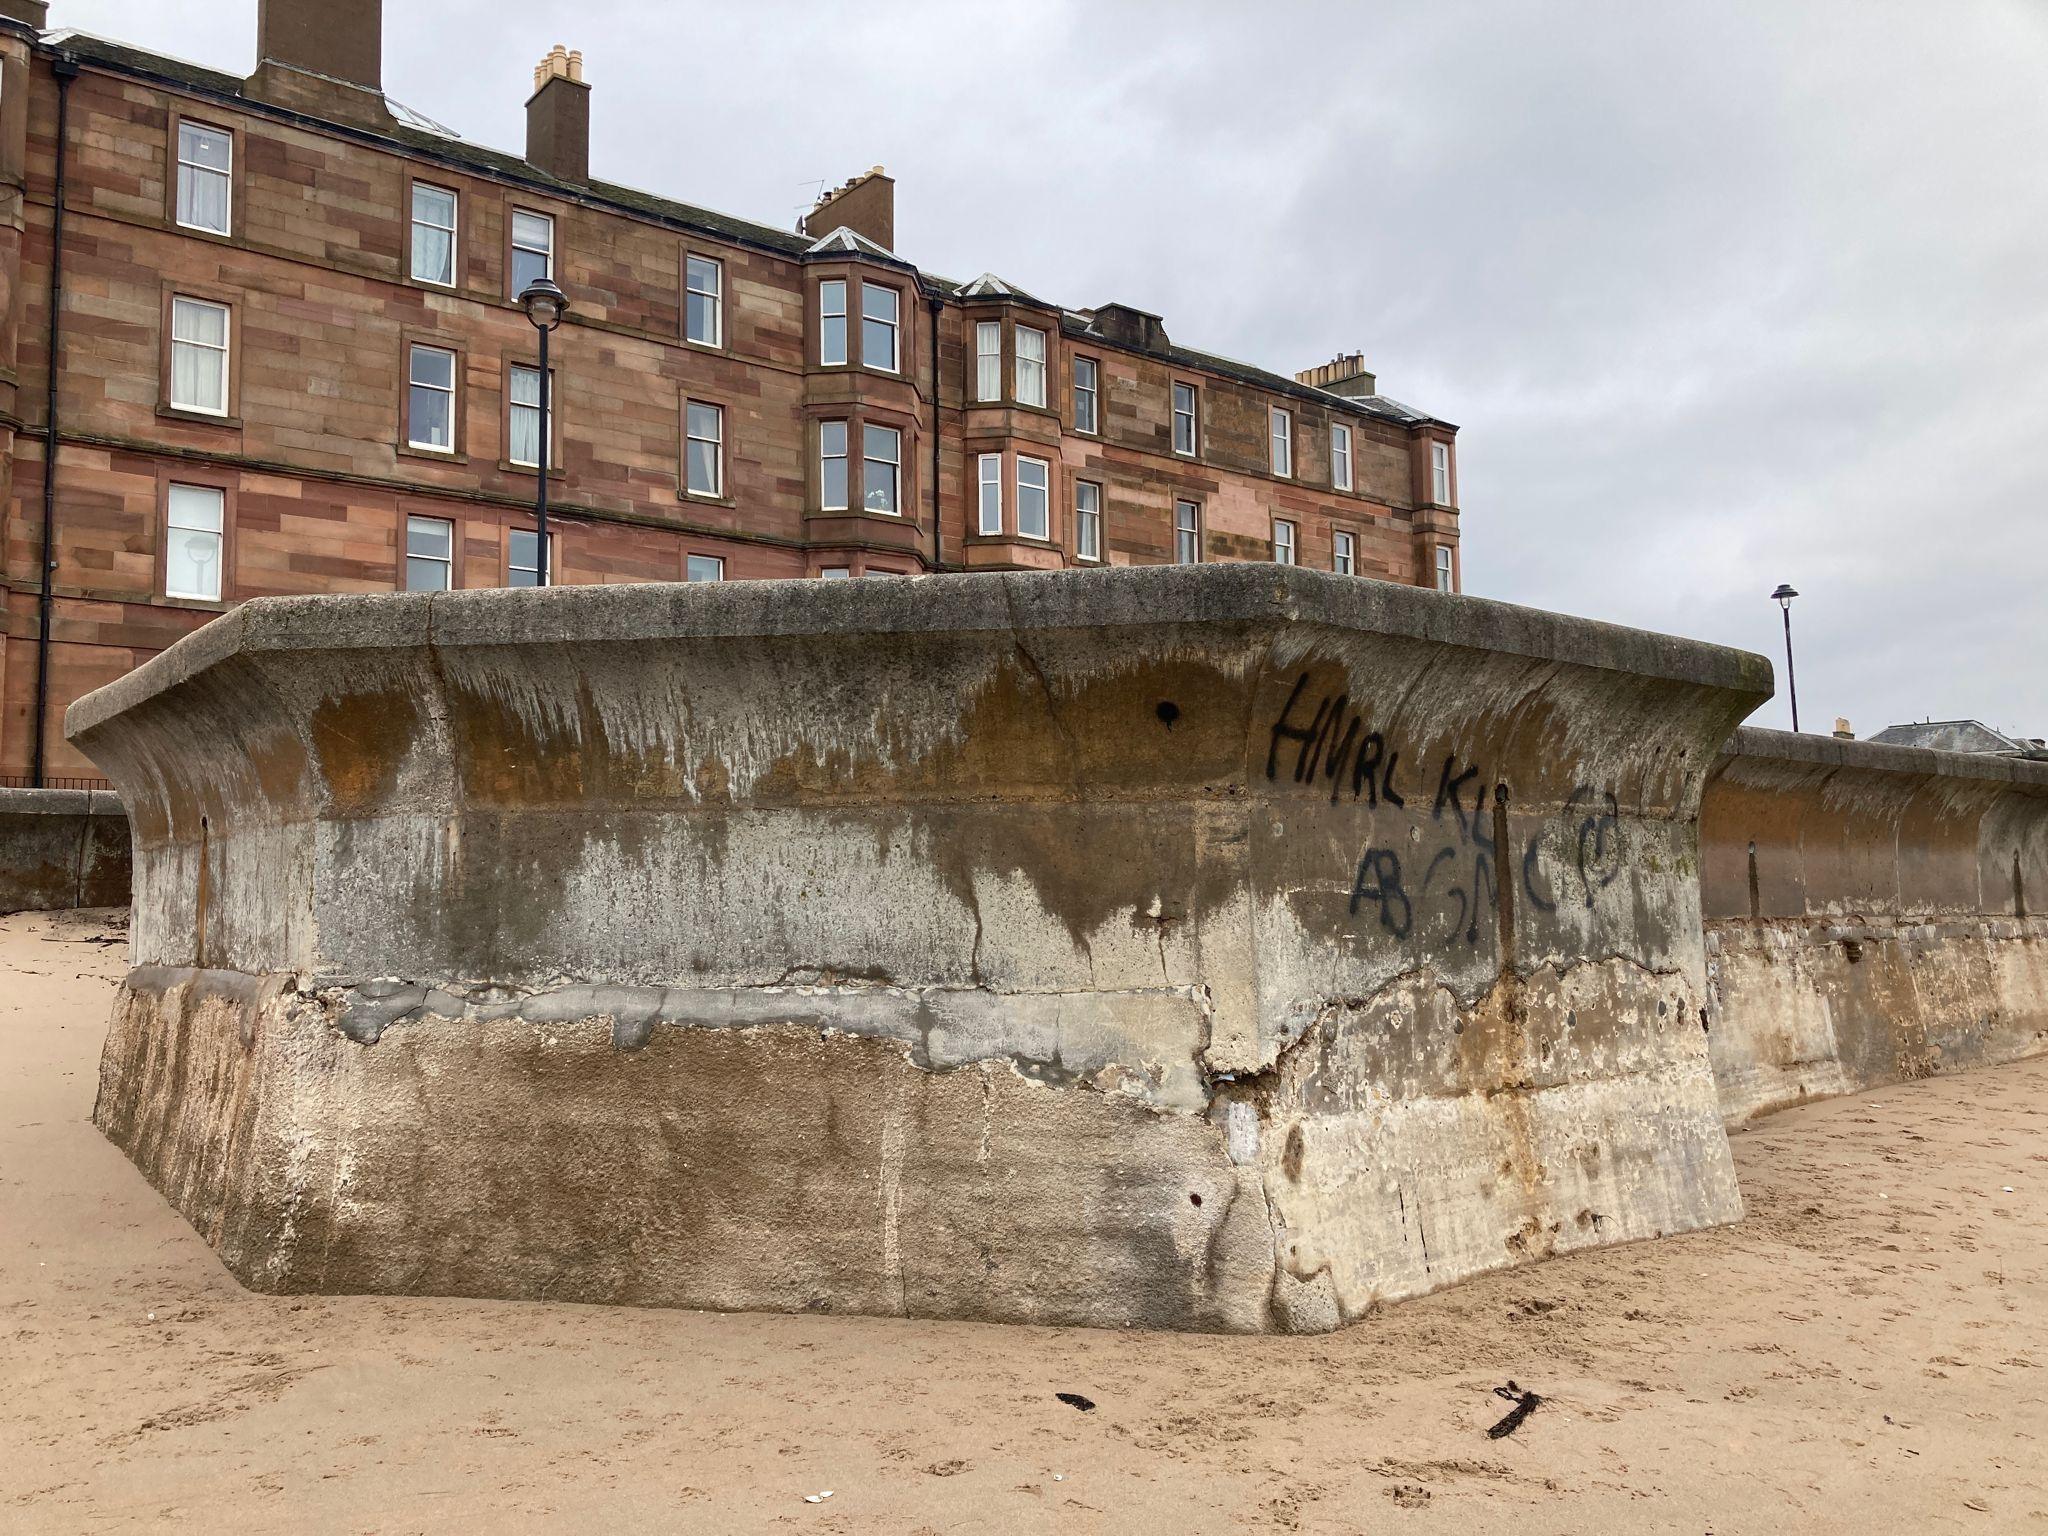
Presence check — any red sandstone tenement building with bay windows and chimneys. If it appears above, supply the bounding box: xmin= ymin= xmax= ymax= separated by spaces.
xmin=0 ymin=0 xmax=1458 ymax=782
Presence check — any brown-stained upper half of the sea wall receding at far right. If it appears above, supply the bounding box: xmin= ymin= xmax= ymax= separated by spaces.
xmin=1700 ymin=729 xmax=2048 ymax=922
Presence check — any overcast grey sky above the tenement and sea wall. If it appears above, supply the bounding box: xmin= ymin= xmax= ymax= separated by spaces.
xmin=51 ymin=0 xmax=2048 ymax=735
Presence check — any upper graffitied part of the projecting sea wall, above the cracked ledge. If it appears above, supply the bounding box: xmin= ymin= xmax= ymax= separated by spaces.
xmin=68 ymin=565 xmax=1769 ymax=1069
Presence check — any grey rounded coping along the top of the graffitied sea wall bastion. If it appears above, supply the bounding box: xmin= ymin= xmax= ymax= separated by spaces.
xmin=66 ymin=563 xmax=1772 ymax=753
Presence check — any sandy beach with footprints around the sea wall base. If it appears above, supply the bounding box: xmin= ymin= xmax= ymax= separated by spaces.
xmin=0 ymin=913 xmax=2048 ymax=1536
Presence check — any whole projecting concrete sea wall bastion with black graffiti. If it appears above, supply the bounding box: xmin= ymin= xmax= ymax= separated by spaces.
xmin=70 ymin=565 xmax=1769 ymax=1329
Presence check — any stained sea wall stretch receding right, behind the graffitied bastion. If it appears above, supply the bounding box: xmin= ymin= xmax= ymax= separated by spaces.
xmin=1700 ymin=729 xmax=2048 ymax=1124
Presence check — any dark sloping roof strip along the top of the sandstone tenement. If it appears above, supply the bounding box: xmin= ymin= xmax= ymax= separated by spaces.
xmin=43 ymin=31 xmax=1456 ymax=432
